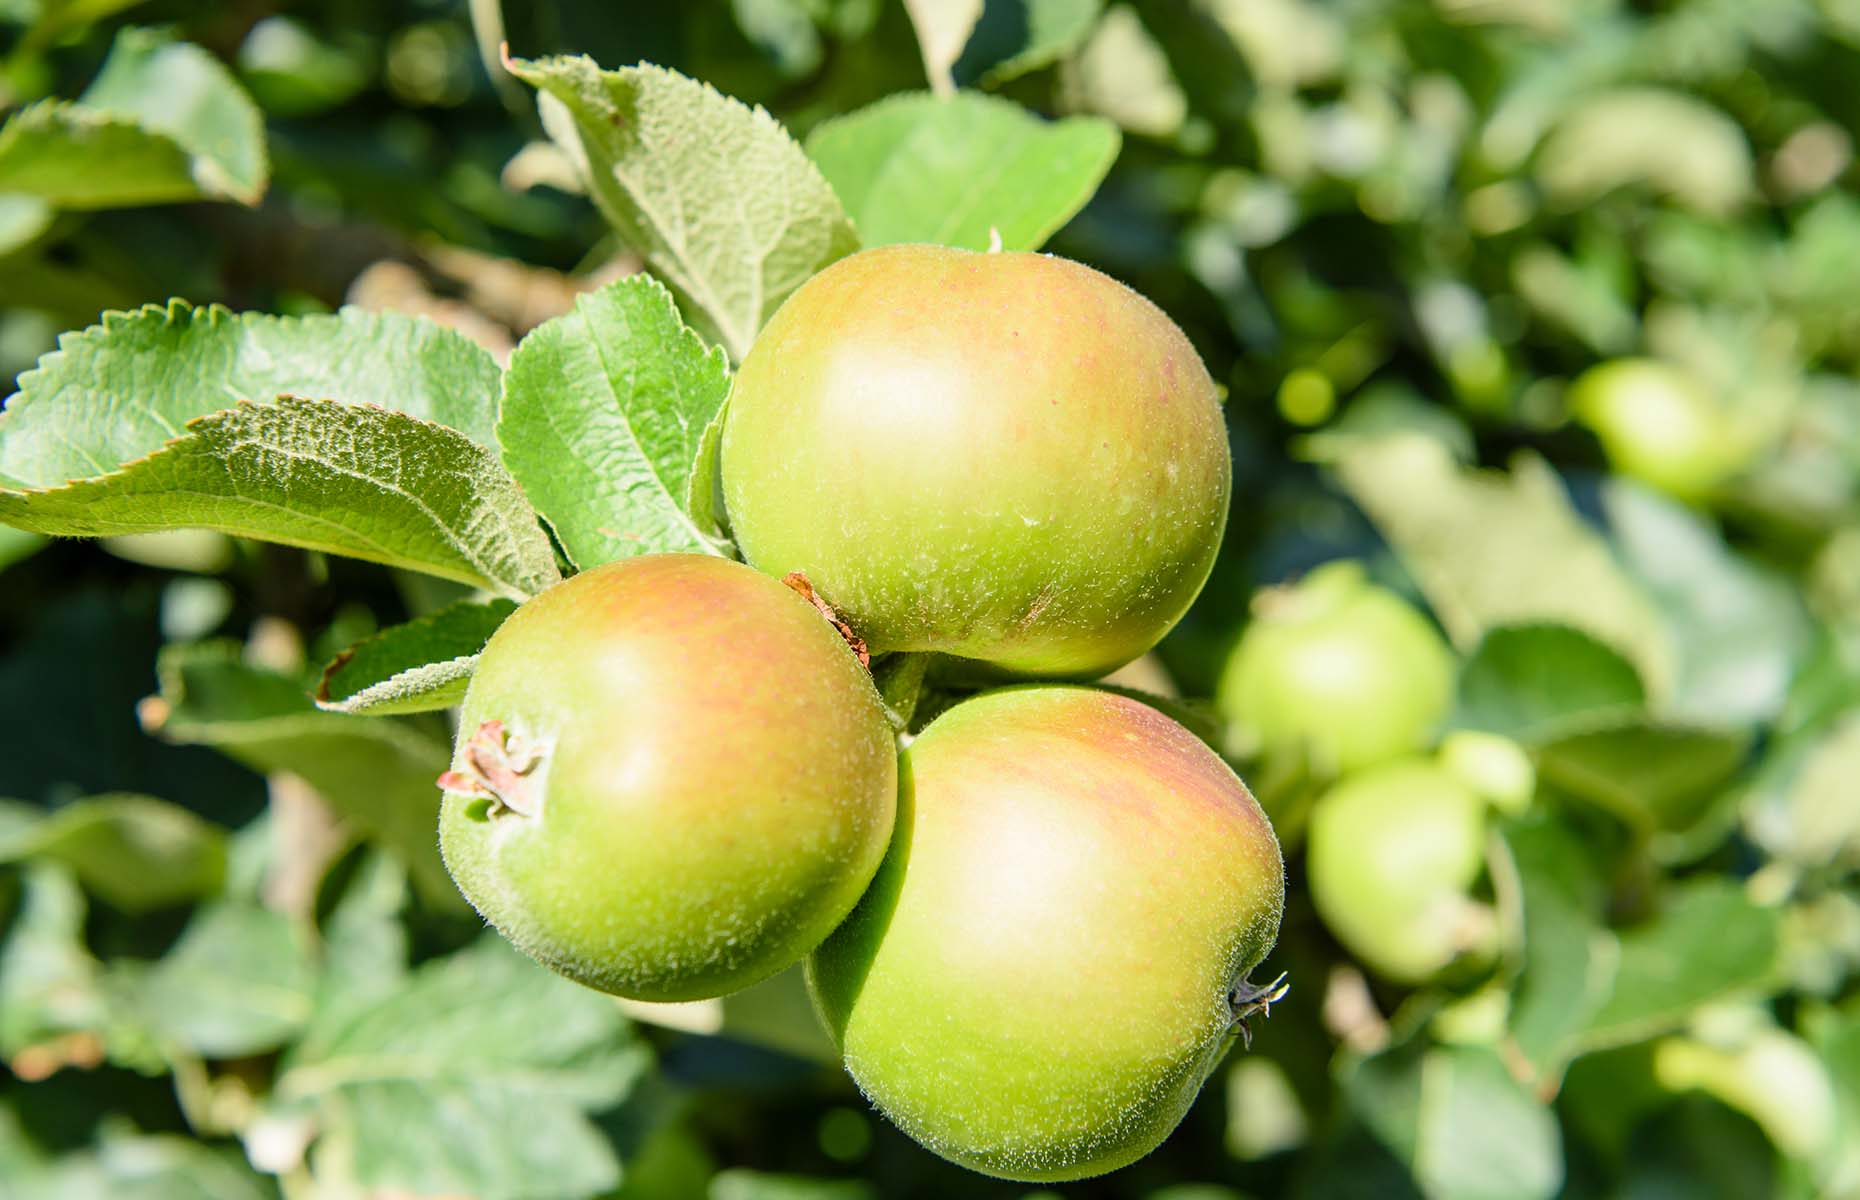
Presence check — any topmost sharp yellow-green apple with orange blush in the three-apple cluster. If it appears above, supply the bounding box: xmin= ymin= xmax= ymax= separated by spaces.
xmin=722 ymin=246 xmax=1233 ymax=679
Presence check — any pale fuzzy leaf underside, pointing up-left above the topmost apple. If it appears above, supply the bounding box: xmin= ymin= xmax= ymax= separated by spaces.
xmin=510 ymin=58 xmax=859 ymax=359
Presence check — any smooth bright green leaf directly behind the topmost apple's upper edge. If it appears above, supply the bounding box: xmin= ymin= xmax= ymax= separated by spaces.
xmin=807 ymin=91 xmax=1122 ymax=249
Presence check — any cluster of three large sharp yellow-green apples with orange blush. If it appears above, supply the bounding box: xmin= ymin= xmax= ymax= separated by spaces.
xmin=441 ymin=246 xmax=1283 ymax=1181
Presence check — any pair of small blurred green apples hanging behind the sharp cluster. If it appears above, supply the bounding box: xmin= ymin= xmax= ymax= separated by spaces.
xmin=1216 ymin=560 xmax=1535 ymax=984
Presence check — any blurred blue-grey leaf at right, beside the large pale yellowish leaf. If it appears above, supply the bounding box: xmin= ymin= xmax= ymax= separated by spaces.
xmin=1601 ymin=476 xmax=1810 ymax=724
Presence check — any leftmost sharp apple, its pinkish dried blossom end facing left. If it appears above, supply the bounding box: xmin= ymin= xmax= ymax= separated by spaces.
xmin=439 ymin=554 xmax=897 ymax=1001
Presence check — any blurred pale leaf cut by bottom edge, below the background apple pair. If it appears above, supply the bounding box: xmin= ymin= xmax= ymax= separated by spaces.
xmin=1341 ymin=1046 xmax=1562 ymax=1200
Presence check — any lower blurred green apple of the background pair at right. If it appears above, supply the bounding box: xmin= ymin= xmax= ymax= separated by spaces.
xmin=1306 ymin=759 xmax=1494 ymax=984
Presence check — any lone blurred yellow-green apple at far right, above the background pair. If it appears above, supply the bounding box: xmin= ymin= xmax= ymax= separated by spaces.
xmin=1570 ymin=359 xmax=1752 ymax=500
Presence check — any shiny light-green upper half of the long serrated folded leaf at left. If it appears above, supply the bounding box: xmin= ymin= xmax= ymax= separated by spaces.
xmin=0 ymin=301 xmax=502 ymax=487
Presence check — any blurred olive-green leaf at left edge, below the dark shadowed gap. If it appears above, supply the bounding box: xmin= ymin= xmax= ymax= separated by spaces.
xmin=0 ymin=796 xmax=227 ymax=912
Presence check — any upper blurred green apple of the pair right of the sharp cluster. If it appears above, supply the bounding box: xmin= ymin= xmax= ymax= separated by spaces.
xmin=1215 ymin=560 xmax=1456 ymax=774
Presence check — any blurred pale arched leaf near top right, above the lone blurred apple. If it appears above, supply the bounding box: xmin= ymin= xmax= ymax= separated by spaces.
xmin=1536 ymin=87 xmax=1754 ymax=216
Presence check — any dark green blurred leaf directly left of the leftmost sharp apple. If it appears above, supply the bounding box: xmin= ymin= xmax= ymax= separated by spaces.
xmin=143 ymin=642 xmax=461 ymax=908
